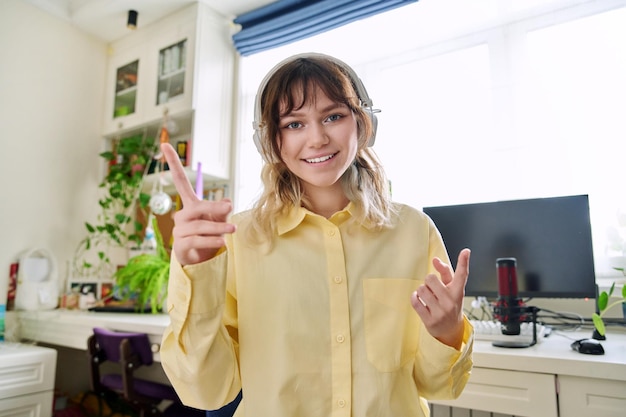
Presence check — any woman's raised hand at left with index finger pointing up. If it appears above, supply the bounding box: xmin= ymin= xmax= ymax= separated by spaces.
xmin=161 ymin=143 xmax=235 ymax=265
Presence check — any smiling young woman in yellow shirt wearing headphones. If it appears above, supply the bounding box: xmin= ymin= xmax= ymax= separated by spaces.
xmin=161 ymin=54 xmax=473 ymax=417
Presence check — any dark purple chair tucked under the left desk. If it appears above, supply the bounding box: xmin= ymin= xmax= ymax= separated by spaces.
xmin=87 ymin=327 xmax=205 ymax=417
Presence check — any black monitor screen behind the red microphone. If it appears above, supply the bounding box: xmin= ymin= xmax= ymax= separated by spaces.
xmin=424 ymin=195 xmax=596 ymax=298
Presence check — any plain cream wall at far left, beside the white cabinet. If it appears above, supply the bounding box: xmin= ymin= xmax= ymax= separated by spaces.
xmin=0 ymin=0 xmax=106 ymax=304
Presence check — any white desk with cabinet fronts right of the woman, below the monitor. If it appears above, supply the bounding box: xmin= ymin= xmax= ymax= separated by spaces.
xmin=433 ymin=330 xmax=626 ymax=417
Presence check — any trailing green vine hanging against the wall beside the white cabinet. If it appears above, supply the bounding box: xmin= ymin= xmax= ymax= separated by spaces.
xmin=73 ymin=135 xmax=157 ymax=278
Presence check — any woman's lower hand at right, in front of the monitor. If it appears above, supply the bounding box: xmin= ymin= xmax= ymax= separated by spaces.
xmin=411 ymin=249 xmax=470 ymax=349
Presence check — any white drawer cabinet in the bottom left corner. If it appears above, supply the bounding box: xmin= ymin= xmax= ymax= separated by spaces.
xmin=0 ymin=343 xmax=57 ymax=417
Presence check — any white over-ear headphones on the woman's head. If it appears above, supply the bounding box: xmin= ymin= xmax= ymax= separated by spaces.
xmin=252 ymin=53 xmax=380 ymax=155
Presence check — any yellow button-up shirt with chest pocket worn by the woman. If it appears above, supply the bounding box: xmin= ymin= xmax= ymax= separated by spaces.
xmin=161 ymin=204 xmax=473 ymax=417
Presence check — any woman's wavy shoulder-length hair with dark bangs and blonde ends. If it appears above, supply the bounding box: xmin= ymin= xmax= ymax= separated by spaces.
xmin=246 ymin=56 xmax=394 ymax=243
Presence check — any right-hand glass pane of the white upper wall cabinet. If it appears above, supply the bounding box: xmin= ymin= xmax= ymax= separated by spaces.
xmin=156 ymin=39 xmax=187 ymax=105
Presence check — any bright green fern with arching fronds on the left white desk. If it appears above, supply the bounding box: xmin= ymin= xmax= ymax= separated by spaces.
xmin=113 ymin=216 xmax=170 ymax=313
